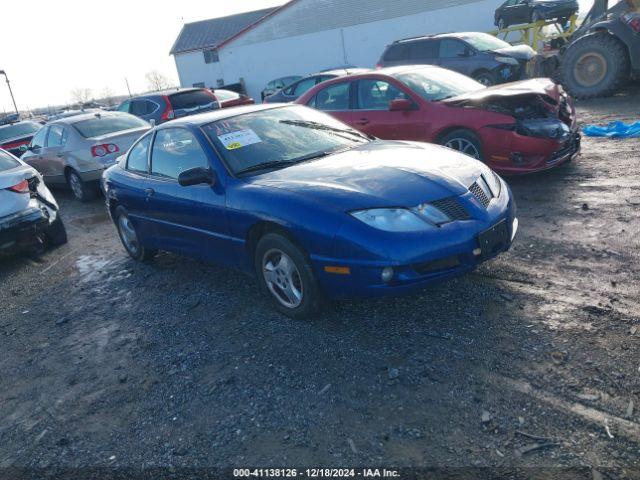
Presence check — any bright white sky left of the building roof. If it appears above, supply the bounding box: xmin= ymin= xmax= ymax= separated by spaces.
xmin=0 ymin=0 xmax=284 ymax=113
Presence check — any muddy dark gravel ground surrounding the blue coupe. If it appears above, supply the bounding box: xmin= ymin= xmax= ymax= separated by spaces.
xmin=0 ymin=90 xmax=640 ymax=478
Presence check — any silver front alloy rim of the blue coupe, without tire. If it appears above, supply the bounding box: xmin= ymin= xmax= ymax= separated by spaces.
xmin=262 ymin=248 xmax=304 ymax=308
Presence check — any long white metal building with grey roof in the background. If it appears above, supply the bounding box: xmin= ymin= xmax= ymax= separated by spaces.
xmin=171 ymin=0 xmax=502 ymax=99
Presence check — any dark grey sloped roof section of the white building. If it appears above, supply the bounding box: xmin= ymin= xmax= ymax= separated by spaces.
xmin=169 ymin=8 xmax=276 ymax=55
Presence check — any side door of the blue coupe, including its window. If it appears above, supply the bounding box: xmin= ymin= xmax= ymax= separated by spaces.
xmin=145 ymin=127 xmax=235 ymax=265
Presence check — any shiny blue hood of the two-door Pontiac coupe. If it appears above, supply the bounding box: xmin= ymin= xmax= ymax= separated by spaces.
xmin=247 ymin=140 xmax=488 ymax=210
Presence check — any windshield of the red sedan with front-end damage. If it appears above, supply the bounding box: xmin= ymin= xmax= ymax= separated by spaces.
xmin=394 ymin=67 xmax=486 ymax=101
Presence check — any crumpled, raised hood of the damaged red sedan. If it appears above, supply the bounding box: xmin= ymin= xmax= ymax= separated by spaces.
xmin=442 ymin=78 xmax=560 ymax=105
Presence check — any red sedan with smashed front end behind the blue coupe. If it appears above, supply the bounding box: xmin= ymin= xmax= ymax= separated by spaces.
xmin=296 ymin=66 xmax=580 ymax=174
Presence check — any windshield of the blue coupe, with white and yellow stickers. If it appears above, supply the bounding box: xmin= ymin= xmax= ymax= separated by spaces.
xmin=202 ymin=105 xmax=369 ymax=173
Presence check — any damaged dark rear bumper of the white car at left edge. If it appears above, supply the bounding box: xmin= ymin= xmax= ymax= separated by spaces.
xmin=0 ymin=199 xmax=57 ymax=254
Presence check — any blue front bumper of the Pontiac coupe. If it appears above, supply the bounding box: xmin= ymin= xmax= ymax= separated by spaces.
xmin=311 ymin=187 xmax=518 ymax=298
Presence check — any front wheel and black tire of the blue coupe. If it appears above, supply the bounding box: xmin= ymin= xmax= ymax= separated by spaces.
xmin=255 ymin=233 xmax=322 ymax=320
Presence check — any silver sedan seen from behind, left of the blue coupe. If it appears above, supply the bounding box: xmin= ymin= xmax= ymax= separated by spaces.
xmin=22 ymin=111 xmax=151 ymax=201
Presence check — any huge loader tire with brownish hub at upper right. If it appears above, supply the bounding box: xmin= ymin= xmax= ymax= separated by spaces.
xmin=560 ymin=32 xmax=630 ymax=98
